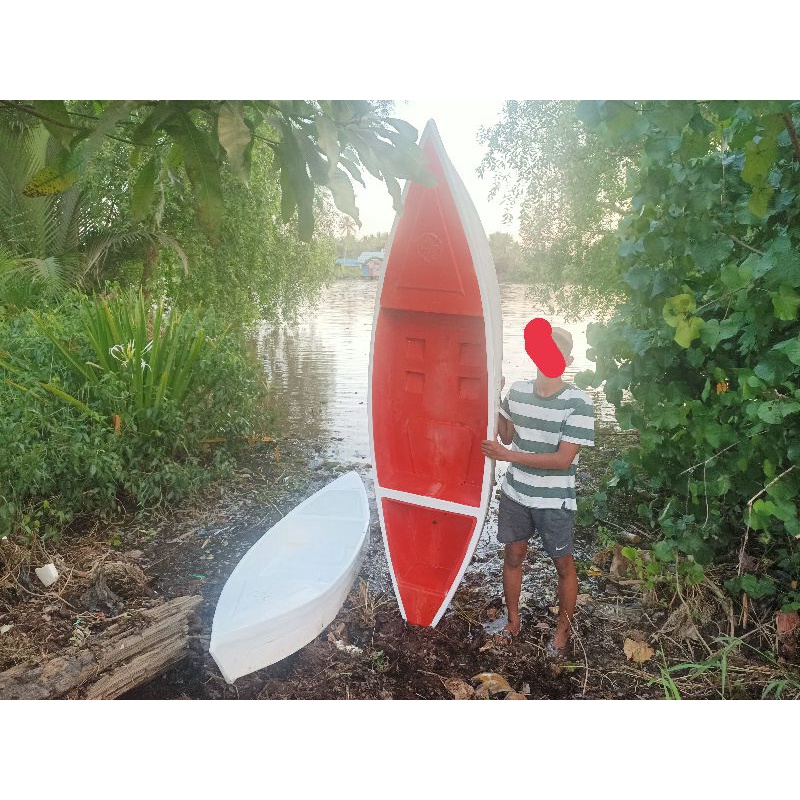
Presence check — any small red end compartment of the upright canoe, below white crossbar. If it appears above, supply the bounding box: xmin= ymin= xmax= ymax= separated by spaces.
xmin=383 ymin=499 xmax=476 ymax=625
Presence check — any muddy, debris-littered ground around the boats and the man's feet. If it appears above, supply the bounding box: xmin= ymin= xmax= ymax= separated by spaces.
xmin=0 ymin=432 xmax=800 ymax=700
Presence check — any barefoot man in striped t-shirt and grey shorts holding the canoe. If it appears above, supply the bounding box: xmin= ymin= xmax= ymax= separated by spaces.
xmin=482 ymin=328 xmax=594 ymax=654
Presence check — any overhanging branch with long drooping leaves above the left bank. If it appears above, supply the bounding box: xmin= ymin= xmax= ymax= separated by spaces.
xmin=0 ymin=100 xmax=433 ymax=242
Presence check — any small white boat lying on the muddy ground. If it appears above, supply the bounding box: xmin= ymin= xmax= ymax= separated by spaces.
xmin=209 ymin=472 xmax=369 ymax=683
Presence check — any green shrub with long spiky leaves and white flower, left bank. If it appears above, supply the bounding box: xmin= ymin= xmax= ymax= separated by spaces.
xmin=0 ymin=293 xmax=268 ymax=535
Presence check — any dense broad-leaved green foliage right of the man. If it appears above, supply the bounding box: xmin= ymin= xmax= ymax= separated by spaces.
xmin=576 ymin=101 xmax=800 ymax=610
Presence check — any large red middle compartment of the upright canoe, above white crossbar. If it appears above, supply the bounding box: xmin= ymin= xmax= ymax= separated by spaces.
xmin=372 ymin=309 xmax=488 ymax=506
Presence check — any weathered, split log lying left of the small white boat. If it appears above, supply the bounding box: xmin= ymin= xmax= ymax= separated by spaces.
xmin=0 ymin=595 xmax=202 ymax=700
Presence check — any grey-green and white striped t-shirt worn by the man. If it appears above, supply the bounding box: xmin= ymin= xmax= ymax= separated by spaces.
xmin=500 ymin=381 xmax=594 ymax=511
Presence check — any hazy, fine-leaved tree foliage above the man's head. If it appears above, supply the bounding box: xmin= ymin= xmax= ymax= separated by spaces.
xmin=479 ymin=100 xmax=637 ymax=317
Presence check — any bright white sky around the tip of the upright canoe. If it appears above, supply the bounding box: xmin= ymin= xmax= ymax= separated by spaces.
xmin=355 ymin=99 xmax=518 ymax=236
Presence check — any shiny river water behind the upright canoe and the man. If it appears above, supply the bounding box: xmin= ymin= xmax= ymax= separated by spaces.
xmin=257 ymin=279 xmax=614 ymax=464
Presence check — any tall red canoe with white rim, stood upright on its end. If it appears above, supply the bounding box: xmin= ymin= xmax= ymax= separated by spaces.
xmin=369 ymin=120 xmax=502 ymax=626
